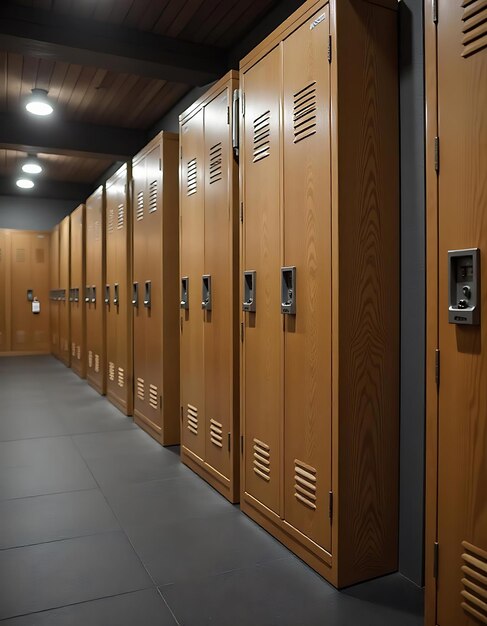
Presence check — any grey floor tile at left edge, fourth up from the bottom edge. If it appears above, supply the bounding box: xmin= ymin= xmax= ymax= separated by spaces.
xmin=0 ymin=437 xmax=96 ymax=500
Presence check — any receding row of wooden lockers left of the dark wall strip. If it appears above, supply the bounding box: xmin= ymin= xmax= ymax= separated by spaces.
xmin=50 ymin=0 xmax=399 ymax=586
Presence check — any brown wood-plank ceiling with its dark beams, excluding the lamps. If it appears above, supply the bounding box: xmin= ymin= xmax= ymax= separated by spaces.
xmin=0 ymin=0 xmax=301 ymax=200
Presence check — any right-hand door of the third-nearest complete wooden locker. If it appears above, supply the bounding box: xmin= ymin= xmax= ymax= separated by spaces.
xmin=141 ymin=144 xmax=164 ymax=434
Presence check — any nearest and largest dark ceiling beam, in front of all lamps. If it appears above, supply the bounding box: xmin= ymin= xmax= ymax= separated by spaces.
xmin=0 ymin=0 xmax=226 ymax=86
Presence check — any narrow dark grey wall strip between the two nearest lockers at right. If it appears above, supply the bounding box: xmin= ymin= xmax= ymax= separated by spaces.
xmin=399 ymin=0 xmax=426 ymax=585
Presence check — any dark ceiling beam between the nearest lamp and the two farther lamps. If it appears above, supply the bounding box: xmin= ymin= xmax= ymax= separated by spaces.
xmin=0 ymin=113 xmax=147 ymax=161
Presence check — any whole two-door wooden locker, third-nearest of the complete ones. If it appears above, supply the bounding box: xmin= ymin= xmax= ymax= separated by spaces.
xmin=132 ymin=133 xmax=179 ymax=445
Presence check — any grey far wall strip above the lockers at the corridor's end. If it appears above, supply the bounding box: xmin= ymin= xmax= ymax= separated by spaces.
xmin=0 ymin=196 xmax=78 ymax=230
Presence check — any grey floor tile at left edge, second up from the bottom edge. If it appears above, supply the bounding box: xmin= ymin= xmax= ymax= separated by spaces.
xmin=0 ymin=532 xmax=152 ymax=619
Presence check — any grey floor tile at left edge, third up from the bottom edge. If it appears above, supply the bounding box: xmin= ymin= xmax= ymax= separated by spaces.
xmin=0 ymin=489 xmax=120 ymax=549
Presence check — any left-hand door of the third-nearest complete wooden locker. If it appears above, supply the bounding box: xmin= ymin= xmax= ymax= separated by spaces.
xmin=131 ymin=157 xmax=149 ymax=415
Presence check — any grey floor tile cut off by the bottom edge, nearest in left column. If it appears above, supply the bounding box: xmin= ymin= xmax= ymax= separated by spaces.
xmin=2 ymin=589 xmax=176 ymax=626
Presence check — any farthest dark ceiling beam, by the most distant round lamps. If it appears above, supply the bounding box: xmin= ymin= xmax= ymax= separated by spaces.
xmin=0 ymin=176 xmax=94 ymax=202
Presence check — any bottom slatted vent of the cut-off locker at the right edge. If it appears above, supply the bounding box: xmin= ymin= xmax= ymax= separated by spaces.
xmin=462 ymin=541 xmax=487 ymax=624
